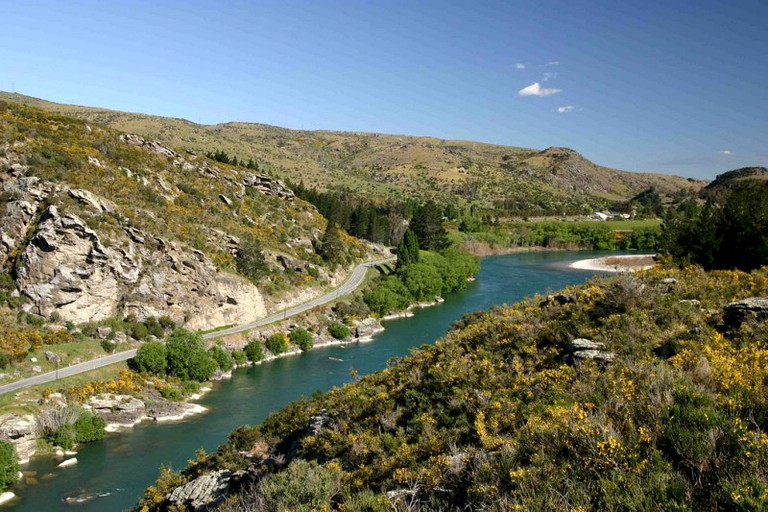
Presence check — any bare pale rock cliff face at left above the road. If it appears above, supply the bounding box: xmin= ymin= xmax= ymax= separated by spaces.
xmin=0 ymin=168 xmax=266 ymax=329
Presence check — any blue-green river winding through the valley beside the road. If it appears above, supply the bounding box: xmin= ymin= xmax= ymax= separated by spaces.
xmin=7 ymin=251 xmax=606 ymax=512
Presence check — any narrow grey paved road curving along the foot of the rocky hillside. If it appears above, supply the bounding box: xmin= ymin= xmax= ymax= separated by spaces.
xmin=0 ymin=257 xmax=395 ymax=395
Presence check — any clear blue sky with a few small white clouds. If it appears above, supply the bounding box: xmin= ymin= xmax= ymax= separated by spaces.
xmin=0 ymin=0 xmax=768 ymax=178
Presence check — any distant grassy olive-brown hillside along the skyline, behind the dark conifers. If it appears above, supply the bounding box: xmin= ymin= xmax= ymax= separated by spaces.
xmin=0 ymin=93 xmax=703 ymax=214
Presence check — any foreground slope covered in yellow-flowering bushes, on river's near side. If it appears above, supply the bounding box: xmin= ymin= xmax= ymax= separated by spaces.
xmin=136 ymin=268 xmax=768 ymax=511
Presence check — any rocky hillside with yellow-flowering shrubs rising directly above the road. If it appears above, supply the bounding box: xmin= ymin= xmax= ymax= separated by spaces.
xmin=0 ymin=101 xmax=370 ymax=329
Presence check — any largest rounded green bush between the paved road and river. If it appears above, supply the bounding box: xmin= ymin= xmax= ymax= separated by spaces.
xmin=166 ymin=329 xmax=216 ymax=382
